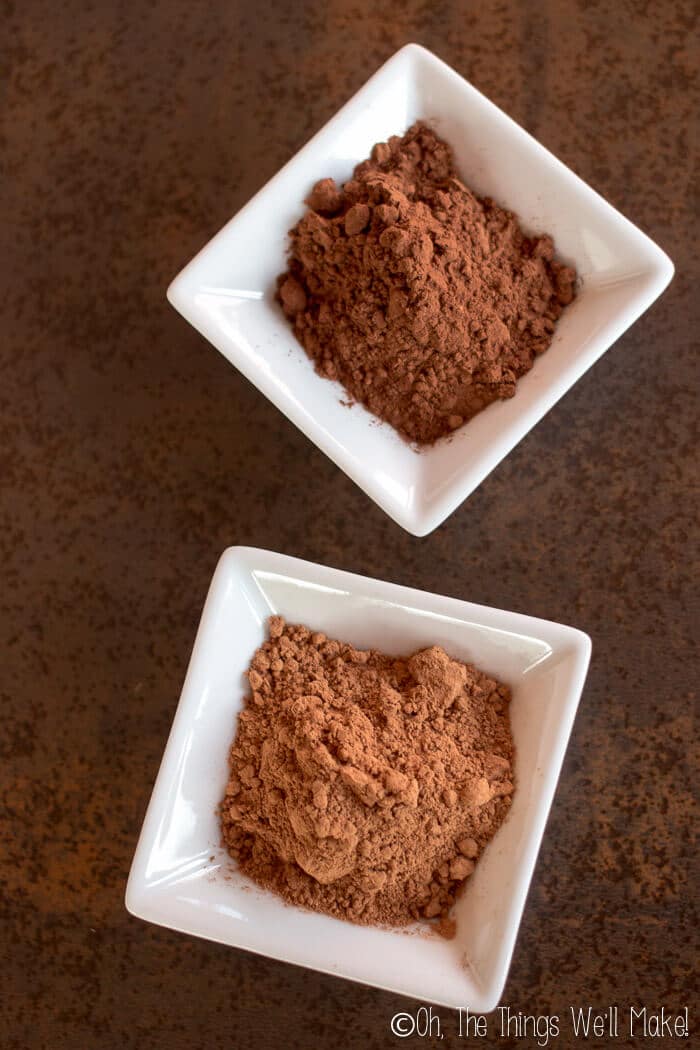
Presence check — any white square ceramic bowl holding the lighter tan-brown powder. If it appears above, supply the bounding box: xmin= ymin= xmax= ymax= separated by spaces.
xmin=126 ymin=547 xmax=591 ymax=1011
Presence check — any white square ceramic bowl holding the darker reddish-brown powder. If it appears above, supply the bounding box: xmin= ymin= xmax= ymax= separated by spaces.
xmin=168 ymin=44 xmax=674 ymax=536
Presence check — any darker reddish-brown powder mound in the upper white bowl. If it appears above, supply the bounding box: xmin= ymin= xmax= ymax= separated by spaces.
xmin=277 ymin=122 xmax=576 ymax=445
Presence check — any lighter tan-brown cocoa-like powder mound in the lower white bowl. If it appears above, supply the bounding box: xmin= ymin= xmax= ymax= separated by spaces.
xmin=221 ymin=616 xmax=513 ymax=936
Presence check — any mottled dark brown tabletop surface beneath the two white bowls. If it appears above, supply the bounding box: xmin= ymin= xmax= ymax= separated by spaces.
xmin=0 ymin=0 xmax=699 ymax=1050
